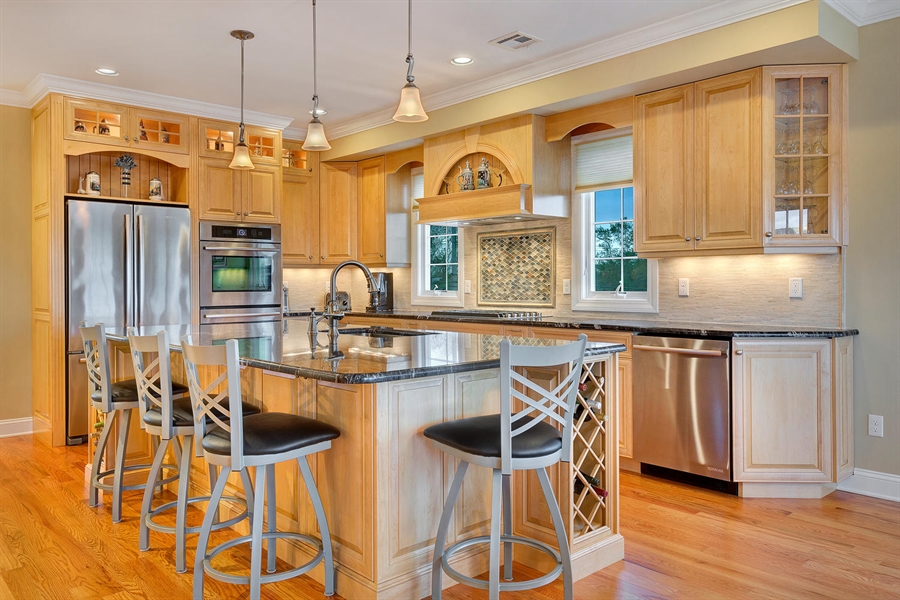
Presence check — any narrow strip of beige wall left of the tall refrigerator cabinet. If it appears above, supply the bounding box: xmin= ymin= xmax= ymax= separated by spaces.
xmin=0 ymin=106 xmax=31 ymax=421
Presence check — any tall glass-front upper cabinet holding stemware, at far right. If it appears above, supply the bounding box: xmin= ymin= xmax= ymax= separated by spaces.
xmin=762 ymin=65 xmax=848 ymax=248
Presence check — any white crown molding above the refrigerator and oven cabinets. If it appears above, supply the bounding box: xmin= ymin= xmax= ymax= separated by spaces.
xmin=0 ymin=73 xmax=294 ymax=129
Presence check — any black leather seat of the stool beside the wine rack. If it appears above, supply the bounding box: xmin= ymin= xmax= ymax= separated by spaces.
xmin=423 ymin=415 xmax=562 ymax=458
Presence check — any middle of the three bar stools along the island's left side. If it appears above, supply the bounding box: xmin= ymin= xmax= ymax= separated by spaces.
xmin=128 ymin=329 xmax=260 ymax=573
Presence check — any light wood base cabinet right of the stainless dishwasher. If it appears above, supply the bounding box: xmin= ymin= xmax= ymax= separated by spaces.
xmin=732 ymin=337 xmax=853 ymax=496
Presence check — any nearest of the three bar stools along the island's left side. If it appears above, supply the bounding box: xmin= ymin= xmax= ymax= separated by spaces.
xmin=181 ymin=336 xmax=341 ymax=600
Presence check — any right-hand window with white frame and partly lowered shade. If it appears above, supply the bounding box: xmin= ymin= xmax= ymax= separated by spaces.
xmin=572 ymin=130 xmax=658 ymax=312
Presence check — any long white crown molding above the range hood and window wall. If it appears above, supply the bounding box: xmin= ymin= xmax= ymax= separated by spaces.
xmin=331 ymin=0 xmax=808 ymax=139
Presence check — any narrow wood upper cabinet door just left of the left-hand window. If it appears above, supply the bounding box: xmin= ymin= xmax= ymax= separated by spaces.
xmin=357 ymin=156 xmax=386 ymax=266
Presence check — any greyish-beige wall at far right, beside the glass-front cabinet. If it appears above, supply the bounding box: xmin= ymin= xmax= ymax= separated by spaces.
xmin=847 ymin=19 xmax=900 ymax=475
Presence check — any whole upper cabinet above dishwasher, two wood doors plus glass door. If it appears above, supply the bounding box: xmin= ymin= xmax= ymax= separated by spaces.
xmin=634 ymin=66 xmax=846 ymax=257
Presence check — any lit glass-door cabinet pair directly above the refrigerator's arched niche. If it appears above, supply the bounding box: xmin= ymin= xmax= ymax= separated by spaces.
xmin=63 ymin=98 xmax=190 ymax=154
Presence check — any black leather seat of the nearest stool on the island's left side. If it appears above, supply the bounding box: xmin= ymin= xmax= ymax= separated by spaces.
xmin=203 ymin=413 xmax=341 ymax=456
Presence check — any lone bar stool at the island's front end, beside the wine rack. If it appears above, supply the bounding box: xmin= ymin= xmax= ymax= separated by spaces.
xmin=424 ymin=334 xmax=587 ymax=600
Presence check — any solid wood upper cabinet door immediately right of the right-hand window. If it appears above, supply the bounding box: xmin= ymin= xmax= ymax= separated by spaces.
xmin=634 ymin=85 xmax=694 ymax=252
